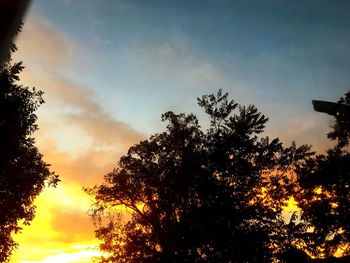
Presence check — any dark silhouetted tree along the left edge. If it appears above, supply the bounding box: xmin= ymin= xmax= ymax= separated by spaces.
xmin=0 ymin=46 xmax=58 ymax=262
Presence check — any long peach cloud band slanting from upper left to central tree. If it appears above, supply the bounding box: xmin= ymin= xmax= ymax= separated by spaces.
xmin=16 ymin=13 xmax=143 ymax=153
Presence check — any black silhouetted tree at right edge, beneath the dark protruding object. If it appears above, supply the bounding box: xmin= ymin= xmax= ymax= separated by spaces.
xmin=296 ymin=92 xmax=350 ymax=262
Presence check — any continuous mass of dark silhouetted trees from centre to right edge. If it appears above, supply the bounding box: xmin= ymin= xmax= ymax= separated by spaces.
xmin=87 ymin=90 xmax=350 ymax=263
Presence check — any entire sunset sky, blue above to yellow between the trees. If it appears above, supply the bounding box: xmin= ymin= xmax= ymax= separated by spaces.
xmin=11 ymin=0 xmax=350 ymax=263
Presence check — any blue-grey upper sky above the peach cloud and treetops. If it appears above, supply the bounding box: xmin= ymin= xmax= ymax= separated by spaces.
xmin=24 ymin=0 xmax=350 ymax=146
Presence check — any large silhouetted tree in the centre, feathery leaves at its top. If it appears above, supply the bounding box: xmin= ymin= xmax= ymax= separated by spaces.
xmin=87 ymin=90 xmax=308 ymax=262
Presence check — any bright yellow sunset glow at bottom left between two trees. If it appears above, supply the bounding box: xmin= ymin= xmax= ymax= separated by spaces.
xmin=11 ymin=184 xmax=101 ymax=263
